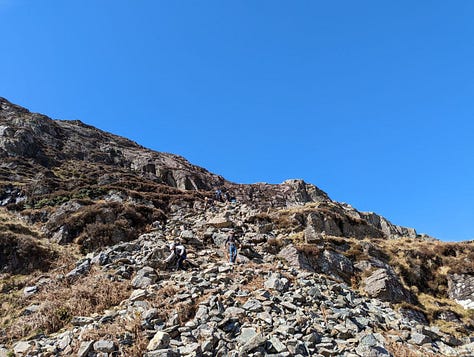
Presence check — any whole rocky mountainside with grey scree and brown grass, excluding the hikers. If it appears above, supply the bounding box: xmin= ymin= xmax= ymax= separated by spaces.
xmin=0 ymin=98 xmax=474 ymax=357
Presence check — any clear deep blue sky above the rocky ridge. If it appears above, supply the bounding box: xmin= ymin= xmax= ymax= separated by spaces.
xmin=0 ymin=0 xmax=474 ymax=241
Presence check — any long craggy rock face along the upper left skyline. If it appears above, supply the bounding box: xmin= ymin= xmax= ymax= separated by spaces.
xmin=0 ymin=98 xmax=224 ymax=190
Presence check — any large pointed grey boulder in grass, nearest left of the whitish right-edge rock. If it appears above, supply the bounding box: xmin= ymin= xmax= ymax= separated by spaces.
xmin=364 ymin=269 xmax=412 ymax=302
